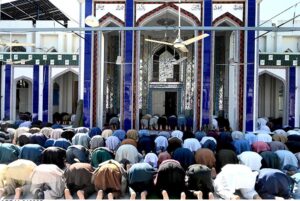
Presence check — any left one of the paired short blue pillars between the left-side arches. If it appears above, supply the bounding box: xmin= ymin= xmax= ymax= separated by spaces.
xmin=32 ymin=65 xmax=40 ymax=121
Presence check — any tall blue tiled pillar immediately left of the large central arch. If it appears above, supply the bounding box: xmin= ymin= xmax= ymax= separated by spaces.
xmin=123 ymin=0 xmax=134 ymax=130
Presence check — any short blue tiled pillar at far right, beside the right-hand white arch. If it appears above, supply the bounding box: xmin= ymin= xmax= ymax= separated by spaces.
xmin=289 ymin=66 xmax=296 ymax=127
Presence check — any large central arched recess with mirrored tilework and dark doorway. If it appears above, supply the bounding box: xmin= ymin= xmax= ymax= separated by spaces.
xmin=137 ymin=6 xmax=200 ymax=130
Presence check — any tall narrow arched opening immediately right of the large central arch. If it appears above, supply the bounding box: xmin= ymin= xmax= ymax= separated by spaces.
xmin=213 ymin=19 xmax=243 ymax=130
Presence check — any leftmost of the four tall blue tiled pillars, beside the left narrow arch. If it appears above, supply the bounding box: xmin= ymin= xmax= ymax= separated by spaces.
xmin=83 ymin=0 xmax=93 ymax=127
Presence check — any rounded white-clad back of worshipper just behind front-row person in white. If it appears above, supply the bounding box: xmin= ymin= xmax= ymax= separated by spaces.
xmin=237 ymin=151 xmax=262 ymax=171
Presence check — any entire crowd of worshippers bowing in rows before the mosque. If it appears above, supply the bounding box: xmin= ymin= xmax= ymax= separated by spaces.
xmin=0 ymin=119 xmax=300 ymax=199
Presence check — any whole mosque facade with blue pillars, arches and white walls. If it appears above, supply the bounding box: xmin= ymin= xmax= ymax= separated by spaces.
xmin=0 ymin=0 xmax=300 ymax=131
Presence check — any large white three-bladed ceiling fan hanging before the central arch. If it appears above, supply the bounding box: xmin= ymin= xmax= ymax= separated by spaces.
xmin=145 ymin=0 xmax=209 ymax=52
